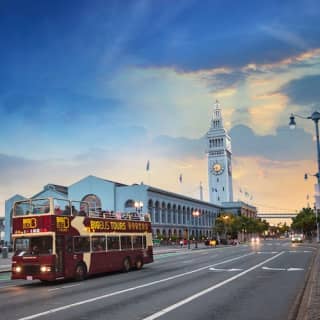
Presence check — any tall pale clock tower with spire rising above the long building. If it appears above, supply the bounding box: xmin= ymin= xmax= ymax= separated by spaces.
xmin=206 ymin=101 xmax=233 ymax=205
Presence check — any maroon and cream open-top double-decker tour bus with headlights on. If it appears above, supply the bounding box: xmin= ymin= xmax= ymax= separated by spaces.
xmin=11 ymin=198 xmax=153 ymax=282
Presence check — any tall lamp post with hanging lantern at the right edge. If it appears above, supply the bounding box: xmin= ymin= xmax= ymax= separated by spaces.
xmin=289 ymin=111 xmax=320 ymax=242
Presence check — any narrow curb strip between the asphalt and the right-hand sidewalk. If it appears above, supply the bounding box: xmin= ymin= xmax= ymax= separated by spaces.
xmin=288 ymin=244 xmax=320 ymax=320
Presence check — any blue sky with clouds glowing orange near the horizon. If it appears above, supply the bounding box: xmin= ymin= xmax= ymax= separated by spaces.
xmin=0 ymin=0 xmax=320 ymax=215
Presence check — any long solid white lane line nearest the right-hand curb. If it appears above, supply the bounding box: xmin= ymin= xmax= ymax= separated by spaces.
xmin=142 ymin=251 xmax=284 ymax=320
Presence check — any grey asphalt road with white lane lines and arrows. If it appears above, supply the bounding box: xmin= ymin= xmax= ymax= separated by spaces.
xmin=0 ymin=240 xmax=314 ymax=320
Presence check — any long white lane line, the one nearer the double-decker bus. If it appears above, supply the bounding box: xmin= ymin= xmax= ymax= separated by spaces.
xmin=18 ymin=252 xmax=254 ymax=320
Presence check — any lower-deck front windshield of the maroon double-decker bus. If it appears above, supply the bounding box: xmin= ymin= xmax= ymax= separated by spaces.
xmin=14 ymin=236 xmax=52 ymax=256
